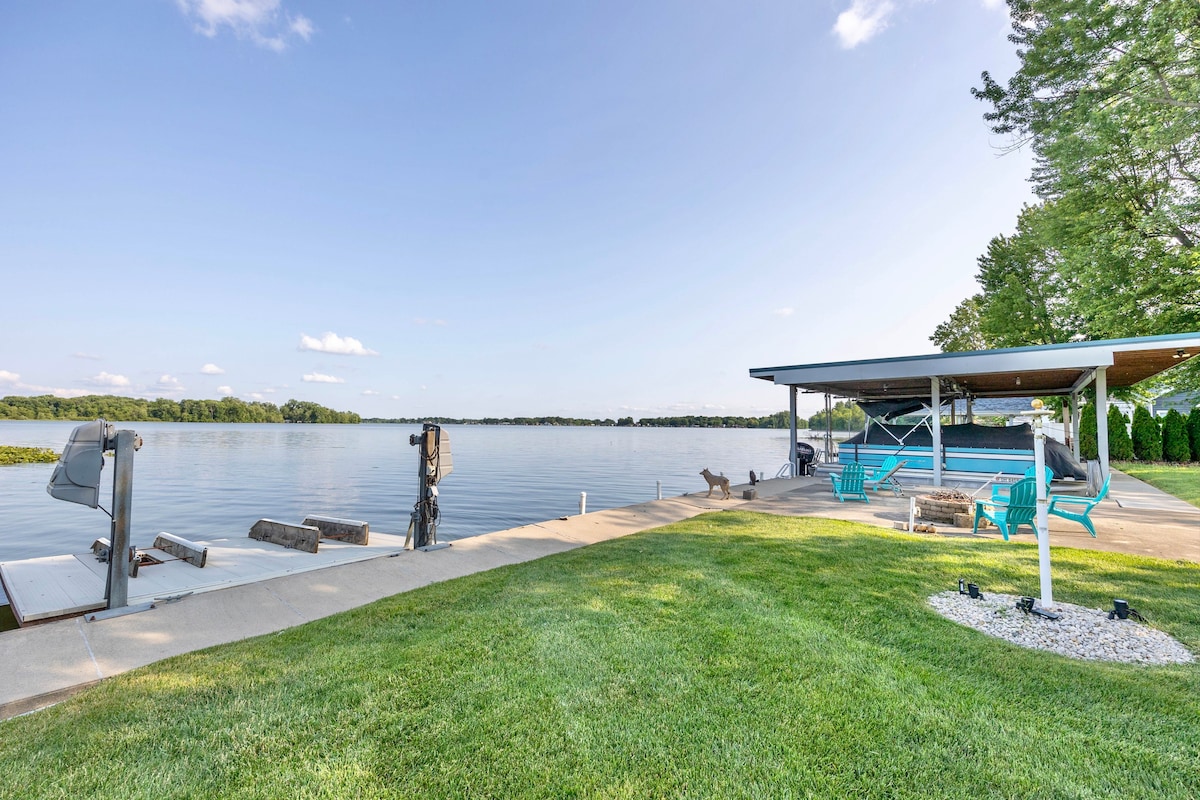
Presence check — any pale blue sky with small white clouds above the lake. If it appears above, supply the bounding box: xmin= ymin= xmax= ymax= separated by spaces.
xmin=0 ymin=0 xmax=1034 ymax=419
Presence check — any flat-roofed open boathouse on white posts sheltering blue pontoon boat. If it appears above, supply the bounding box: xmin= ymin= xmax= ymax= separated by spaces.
xmin=750 ymin=332 xmax=1200 ymax=486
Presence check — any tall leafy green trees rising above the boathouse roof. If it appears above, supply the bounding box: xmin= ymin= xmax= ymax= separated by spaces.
xmin=931 ymin=0 xmax=1200 ymax=387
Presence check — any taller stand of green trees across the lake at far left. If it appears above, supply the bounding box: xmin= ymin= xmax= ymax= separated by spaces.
xmin=0 ymin=395 xmax=362 ymax=425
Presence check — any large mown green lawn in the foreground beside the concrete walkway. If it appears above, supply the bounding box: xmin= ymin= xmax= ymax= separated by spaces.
xmin=0 ymin=512 xmax=1200 ymax=799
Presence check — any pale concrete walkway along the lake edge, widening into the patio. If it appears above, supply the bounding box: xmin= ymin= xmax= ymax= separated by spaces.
xmin=0 ymin=473 xmax=1200 ymax=720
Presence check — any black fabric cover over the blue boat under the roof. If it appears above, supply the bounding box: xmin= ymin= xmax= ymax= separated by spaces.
xmin=846 ymin=422 xmax=1087 ymax=481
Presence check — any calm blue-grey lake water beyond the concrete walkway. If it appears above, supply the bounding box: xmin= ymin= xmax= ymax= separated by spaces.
xmin=0 ymin=421 xmax=806 ymax=597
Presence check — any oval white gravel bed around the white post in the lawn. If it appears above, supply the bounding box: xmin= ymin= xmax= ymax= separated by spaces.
xmin=929 ymin=590 xmax=1195 ymax=664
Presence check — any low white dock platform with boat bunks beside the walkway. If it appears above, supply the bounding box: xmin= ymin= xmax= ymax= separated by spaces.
xmin=0 ymin=531 xmax=404 ymax=626
